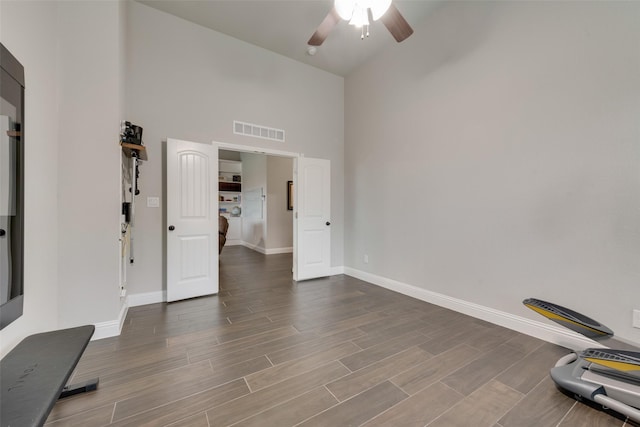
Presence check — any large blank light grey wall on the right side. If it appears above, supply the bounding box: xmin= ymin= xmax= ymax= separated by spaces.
xmin=345 ymin=1 xmax=640 ymax=343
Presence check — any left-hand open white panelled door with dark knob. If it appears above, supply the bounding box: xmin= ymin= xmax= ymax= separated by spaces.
xmin=166 ymin=139 xmax=218 ymax=302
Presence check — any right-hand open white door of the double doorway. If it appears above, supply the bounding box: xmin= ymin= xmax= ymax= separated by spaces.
xmin=293 ymin=157 xmax=331 ymax=280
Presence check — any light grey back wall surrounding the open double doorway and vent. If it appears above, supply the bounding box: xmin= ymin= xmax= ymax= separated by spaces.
xmin=126 ymin=2 xmax=344 ymax=293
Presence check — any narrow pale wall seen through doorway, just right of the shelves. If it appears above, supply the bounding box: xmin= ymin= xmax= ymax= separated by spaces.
xmin=240 ymin=153 xmax=267 ymax=252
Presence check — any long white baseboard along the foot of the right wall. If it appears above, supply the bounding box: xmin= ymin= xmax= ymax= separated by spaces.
xmin=344 ymin=267 xmax=603 ymax=350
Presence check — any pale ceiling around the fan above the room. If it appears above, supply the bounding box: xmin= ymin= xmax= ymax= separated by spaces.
xmin=137 ymin=0 xmax=437 ymax=76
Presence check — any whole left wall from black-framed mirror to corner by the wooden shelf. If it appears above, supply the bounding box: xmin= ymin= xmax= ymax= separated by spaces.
xmin=0 ymin=1 xmax=124 ymax=355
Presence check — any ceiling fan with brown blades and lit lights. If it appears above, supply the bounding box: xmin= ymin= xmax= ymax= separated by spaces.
xmin=307 ymin=0 xmax=413 ymax=46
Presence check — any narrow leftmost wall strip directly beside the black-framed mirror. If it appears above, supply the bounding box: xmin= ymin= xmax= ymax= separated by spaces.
xmin=0 ymin=0 xmax=59 ymax=357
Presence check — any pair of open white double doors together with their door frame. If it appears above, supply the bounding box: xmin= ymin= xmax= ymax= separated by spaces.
xmin=165 ymin=139 xmax=331 ymax=302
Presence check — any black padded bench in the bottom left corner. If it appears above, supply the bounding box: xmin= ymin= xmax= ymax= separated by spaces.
xmin=0 ymin=325 xmax=98 ymax=427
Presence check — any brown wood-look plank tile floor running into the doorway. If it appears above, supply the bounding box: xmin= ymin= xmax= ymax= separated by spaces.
xmin=47 ymin=246 xmax=638 ymax=427
